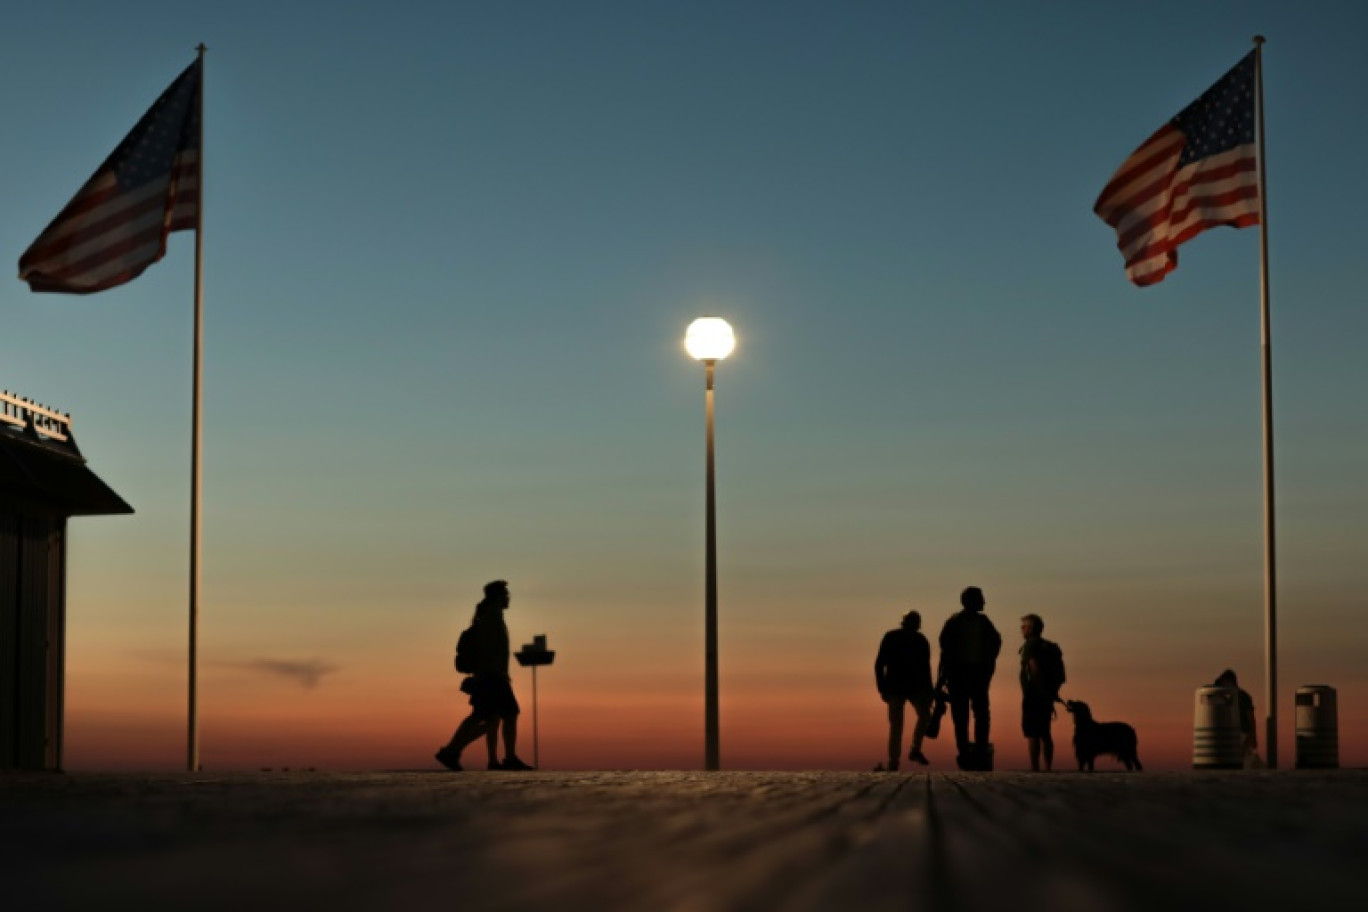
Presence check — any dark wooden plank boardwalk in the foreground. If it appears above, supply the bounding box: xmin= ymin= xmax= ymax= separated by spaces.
xmin=0 ymin=771 xmax=1368 ymax=912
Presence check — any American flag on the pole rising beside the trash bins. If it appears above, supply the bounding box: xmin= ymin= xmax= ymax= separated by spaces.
xmin=1093 ymin=51 xmax=1260 ymax=286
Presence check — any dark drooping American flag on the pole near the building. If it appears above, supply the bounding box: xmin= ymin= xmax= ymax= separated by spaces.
xmin=19 ymin=60 xmax=201 ymax=294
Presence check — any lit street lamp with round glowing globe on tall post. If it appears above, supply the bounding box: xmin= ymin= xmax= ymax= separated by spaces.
xmin=684 ymin=317 xmax=736 ymax=770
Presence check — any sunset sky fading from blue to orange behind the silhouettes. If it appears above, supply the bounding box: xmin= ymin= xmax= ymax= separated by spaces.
xmin=0 ymin=0 xmax=1368 ymax=770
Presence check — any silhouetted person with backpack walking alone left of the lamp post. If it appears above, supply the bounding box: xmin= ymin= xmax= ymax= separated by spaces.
xmin=436 ymin=580 xmax=532 ymax=770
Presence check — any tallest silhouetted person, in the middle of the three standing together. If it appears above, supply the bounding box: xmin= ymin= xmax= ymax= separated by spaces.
xmin=936 ymin=585 xmax=1003 ymax=770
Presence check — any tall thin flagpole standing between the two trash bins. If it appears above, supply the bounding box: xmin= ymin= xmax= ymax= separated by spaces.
xmin=1254 ymin=36 xmax=1278 ymax=770
